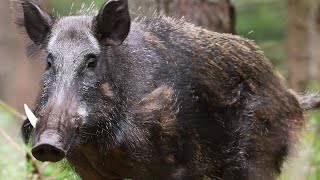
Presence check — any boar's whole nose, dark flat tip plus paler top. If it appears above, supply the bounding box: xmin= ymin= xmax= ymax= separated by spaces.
xmin=31 ymin=133 xmax=66 ymax=162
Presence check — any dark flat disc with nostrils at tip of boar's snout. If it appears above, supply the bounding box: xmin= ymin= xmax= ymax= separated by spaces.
xmin=32 ymin=144 xmax=66 ymax=162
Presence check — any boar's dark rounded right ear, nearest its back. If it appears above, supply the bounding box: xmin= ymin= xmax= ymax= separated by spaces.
xmin=93 ymin=0 xmax=130 ymax=46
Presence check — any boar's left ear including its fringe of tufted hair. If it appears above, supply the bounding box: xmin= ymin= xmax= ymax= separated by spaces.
xmin=12 ymin=0 xmax=54 ymax=54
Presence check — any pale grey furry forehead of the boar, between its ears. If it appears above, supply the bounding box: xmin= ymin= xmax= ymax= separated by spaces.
xmin=47 ymin=16 xmax=100 ymax=71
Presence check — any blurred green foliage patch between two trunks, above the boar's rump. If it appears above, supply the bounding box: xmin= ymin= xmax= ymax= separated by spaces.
xmin=235 ymin=0 xmax=286 ymax=42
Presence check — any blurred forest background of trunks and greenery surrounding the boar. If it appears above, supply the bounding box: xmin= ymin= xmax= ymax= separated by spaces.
xmin=0 ymin=0 xmax=320 ymax=180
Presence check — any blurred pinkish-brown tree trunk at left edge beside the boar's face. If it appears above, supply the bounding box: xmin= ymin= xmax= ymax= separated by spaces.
xmin=0 ymin=0 xmax=41 ymax=112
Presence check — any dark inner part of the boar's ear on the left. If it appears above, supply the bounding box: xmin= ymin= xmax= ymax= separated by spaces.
xmin=18 ymin=0 xmax=53 ymax=45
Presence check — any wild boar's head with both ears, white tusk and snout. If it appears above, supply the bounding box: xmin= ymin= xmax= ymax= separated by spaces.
xmin=17 ymin=0 xmax=130 ymax=162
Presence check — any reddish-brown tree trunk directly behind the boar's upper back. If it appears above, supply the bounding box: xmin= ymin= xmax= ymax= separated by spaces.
xmin=133 ymin=0 xmax=235 ymax=33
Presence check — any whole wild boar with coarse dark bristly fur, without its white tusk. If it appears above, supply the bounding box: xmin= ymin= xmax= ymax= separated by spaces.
xmin=13 ymin=0 xmax=320 ymax=180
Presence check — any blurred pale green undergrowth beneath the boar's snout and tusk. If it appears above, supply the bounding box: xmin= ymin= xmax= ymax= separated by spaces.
xmin=0 ymin=102 xmax=80 ymax=180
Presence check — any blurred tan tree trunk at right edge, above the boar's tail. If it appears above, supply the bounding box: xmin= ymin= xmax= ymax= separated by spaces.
xmin=287 ymin=0 xmax=320 ymax=91
